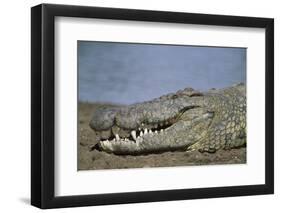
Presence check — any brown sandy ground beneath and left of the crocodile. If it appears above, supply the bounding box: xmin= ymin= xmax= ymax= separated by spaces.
xmin=78 ymin=103 xmax=246 ymax=170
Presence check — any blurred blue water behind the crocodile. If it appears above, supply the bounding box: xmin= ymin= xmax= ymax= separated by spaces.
xmin=78 ymin=41 xmax=246 ymax=104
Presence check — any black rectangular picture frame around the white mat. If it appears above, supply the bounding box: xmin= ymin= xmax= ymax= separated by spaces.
xmin=31 ymin=4 xmax=274 ymax=209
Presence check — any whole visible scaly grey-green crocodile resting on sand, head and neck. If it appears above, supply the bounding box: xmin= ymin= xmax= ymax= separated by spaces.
xmin=89 ymin=83 xmax=246 ymax=155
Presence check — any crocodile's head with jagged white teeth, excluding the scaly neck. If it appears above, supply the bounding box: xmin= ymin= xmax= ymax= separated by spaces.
xmin=90 ymin=88 xmax=214 ymax=154
